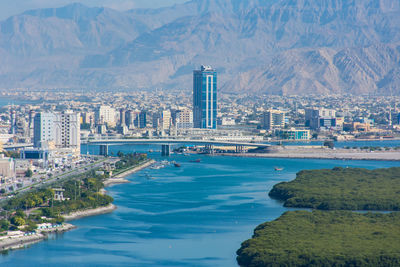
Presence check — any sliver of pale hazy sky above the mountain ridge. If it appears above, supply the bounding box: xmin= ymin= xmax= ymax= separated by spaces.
xmin=0 ymin=0 xmax=188 ymax=20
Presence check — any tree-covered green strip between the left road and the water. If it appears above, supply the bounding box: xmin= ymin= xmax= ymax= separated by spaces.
xmin=0 ymin=153 xmax=147 ymax=250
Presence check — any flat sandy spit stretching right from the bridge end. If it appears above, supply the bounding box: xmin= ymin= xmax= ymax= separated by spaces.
xmin=222 ymin=150 xmax=400 ymax=161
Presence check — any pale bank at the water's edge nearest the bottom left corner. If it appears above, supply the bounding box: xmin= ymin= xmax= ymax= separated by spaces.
xmin=0 ymin=223 xmax=76 ymax=251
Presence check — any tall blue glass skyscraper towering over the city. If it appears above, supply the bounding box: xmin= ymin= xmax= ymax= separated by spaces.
xmin=193 ymin=66 xmax=217 ymax=129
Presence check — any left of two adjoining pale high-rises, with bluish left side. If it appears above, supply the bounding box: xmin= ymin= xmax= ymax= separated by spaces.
xmin=33 ymin=112 xmax=55 ymax=147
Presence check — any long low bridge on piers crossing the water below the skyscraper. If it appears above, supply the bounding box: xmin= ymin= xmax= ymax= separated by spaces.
xmin=82 ymin=139 xmax=271 ymax=156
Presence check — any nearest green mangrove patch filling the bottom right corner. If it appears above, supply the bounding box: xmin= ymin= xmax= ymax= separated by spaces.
xmin=237 ymin=211 xmax=400 ymax=267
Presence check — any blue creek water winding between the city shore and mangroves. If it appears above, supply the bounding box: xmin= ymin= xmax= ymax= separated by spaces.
xmin=0 ymin=147 xmax=400 ymax=267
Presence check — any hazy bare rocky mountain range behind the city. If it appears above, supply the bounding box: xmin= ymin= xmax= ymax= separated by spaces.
xmin=0 ymin=0 xmax=400 ymax=95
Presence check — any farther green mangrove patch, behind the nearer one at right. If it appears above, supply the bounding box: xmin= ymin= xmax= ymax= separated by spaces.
xmin=269 ymin=167 xmax=400 ymax=211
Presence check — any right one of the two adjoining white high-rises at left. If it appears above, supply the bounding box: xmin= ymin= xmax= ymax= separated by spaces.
xmin=54 ymin=111 xmax=81 ymax=154
